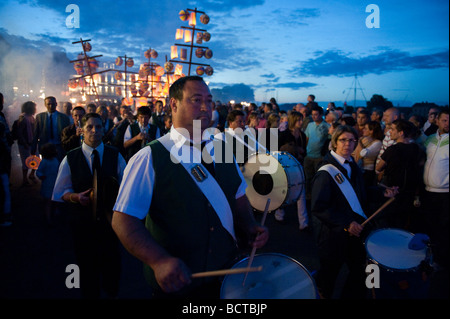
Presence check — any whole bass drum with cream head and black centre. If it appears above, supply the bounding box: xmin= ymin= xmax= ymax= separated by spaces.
xmin=242 ymin=152 xmax=305 ymax=211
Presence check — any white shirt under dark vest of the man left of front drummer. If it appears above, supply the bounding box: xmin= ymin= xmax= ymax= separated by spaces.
xmin=52 ymin=143 xmax=127 ymax=202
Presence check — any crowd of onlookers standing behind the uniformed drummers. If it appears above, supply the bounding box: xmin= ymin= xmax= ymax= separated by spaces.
xmin=0 ymin=95 xmax=449 ymax=300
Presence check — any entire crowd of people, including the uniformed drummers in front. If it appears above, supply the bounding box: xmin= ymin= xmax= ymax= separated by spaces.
xmin=0 ymin=82 xmax=449 ymax=298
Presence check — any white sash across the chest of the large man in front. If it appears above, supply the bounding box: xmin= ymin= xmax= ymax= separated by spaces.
xmin=158 ymin=134 xmax=236 ymax=240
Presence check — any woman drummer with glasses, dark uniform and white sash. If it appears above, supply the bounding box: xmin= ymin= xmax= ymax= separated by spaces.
xmin=311 ymin=125 xmax=395 ymax=299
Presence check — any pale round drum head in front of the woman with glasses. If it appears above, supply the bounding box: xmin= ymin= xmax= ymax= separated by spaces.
xmin=365 ymin=228 xmax=427 ymax=270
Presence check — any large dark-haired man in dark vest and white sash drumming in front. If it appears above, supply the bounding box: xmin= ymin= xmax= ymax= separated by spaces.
xmin=112 ymin=76 xmax=268 ymax=298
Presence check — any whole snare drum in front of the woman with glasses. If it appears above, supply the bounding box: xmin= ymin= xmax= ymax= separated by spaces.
xmin=365 ymin=228 xmax=429 ymax=299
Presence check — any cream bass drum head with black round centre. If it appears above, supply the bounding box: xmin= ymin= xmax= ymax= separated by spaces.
xmin=242 ymin=153 xmax=288 ymax=212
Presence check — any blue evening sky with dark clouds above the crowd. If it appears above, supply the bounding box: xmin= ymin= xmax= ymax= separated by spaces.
xmin=0 ymin=0 xmax=449 ymax=106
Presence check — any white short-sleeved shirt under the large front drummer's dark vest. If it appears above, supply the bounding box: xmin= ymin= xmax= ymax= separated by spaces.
xmin=114 ymin=126 xmax=247 ymax=219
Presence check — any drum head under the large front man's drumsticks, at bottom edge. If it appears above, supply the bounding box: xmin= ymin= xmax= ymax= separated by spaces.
xmin=220 ymin=254 xmax=317 ymax=299
